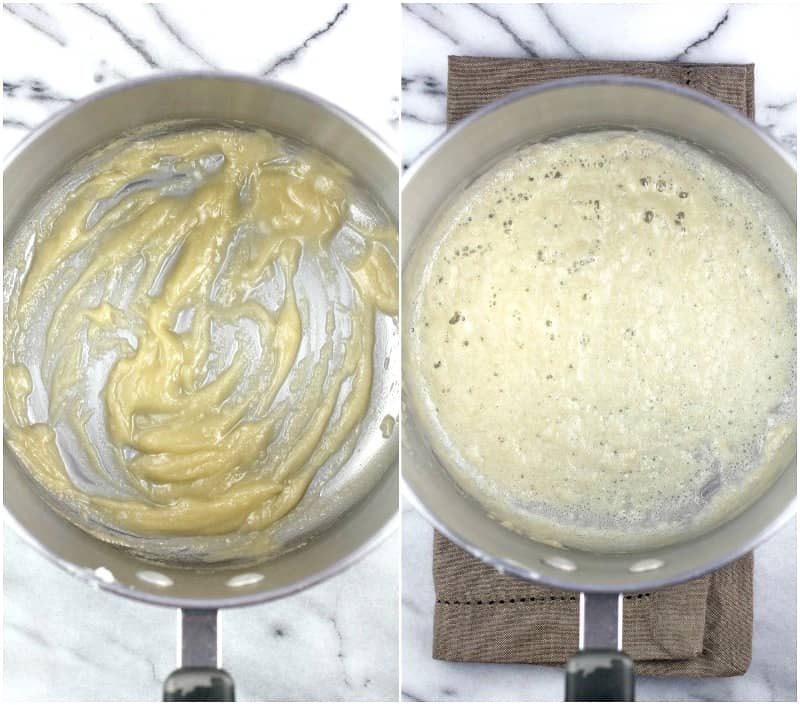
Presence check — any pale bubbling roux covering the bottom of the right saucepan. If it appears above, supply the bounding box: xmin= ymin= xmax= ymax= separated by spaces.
xmin=404 ymin=131 xmax=796 ymax=551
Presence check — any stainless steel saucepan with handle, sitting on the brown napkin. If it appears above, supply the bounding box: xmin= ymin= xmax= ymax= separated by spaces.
xmin=401 ymin=76 xmax=797 ymax=700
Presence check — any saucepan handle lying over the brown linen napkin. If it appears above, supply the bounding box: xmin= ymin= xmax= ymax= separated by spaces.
xmin=565 ymin=592 xmax=634 ymax=702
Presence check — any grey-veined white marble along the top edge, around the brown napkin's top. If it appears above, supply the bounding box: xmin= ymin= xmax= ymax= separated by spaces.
xmin=402 ymin=3 xmax=800 ymax=166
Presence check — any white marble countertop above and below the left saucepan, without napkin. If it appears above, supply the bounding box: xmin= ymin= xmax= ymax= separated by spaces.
xmin=2 ymin=2 xmax=400 ymax=701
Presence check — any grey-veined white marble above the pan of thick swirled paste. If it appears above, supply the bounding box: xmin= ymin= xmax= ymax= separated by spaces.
xmin=0 ymin=0 xmax=400 ymax=153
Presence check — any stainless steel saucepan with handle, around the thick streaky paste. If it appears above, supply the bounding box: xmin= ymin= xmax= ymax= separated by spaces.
xmin=3 ymin=73 xmax=400 ymax=700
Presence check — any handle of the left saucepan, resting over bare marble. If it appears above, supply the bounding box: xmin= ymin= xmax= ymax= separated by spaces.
xmin=164 ymin=609 xmax=236 ymax=702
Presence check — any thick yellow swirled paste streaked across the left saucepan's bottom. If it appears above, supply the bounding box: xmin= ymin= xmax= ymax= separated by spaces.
xmin=4 ymin=128 xmax=397 ymax=556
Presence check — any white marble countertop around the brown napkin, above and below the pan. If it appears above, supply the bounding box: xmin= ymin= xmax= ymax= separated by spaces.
xmin=402 ymin=3 xmax=800 ymax=701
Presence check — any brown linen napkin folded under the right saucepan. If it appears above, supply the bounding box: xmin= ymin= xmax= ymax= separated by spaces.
xmin=433 ymin=56 xmax=753 ymax=676
